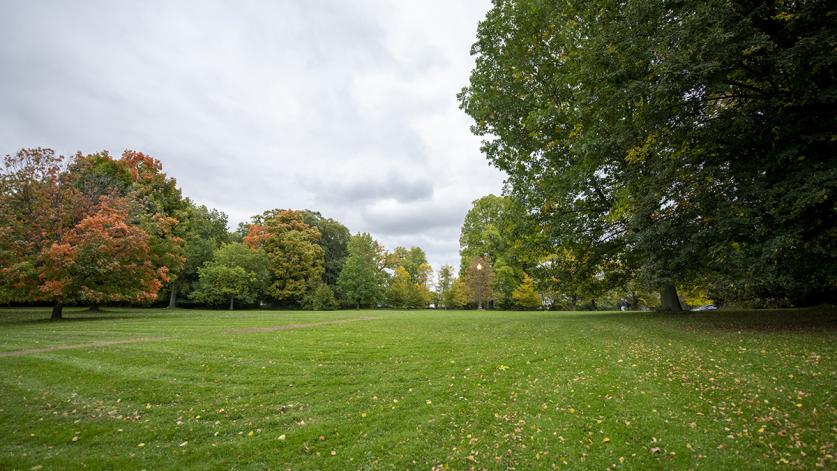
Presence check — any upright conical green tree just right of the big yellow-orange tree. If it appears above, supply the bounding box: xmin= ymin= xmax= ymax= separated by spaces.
xmin=337 ymin=232 xmax=386 ymax=307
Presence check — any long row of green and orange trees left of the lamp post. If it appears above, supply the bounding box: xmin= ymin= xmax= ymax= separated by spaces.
xmin=0 ymin=148 xmax=502 ymax=318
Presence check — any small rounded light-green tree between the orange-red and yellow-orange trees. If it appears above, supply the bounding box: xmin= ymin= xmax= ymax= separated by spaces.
xmin=190 ymin=243 xmax=270 ymax=309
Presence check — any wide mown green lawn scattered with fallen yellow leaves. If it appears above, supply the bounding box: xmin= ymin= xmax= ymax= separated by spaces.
xmin=0 ymin=309 xmax=837 ymax=470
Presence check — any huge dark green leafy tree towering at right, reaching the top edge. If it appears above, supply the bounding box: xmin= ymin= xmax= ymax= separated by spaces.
xmin=460 ymin=0 xmax=837 ymax=310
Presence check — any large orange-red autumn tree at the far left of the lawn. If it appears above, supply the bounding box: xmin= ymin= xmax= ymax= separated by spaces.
xmin=0 ymin=149 xmax=183 ymax=319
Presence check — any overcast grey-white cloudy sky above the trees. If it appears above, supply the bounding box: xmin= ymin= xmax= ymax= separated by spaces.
xmin=0 ymin=0 xmax=503 ymax=268
